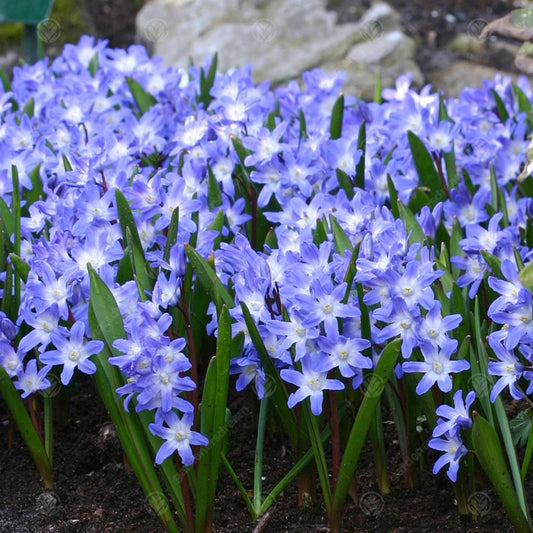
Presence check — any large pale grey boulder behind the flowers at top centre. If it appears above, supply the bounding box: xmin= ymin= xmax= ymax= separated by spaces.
xmin=137 ymin=0 xmax=423 ymax=96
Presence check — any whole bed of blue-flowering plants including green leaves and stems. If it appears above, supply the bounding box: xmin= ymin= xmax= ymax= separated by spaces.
xmin=0 ymin=37 xmax=533 ymax=532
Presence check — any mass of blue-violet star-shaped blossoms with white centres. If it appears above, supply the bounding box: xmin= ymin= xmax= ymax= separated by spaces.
xmin=0 ymin=37 xmax=533 ymax=479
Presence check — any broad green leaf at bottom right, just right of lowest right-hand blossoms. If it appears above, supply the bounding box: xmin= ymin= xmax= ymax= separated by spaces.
xmin=472 ymin=412 xmax=532 ymax=532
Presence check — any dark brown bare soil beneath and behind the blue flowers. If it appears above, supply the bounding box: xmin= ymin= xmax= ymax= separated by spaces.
xmin=0 ymin=0 xmax=528 ymax=533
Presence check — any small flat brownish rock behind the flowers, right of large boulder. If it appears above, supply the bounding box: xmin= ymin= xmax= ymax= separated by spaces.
xmin=429 ymin=61 xmax=517 ymax=97
